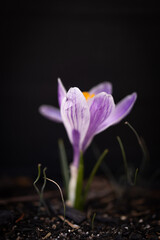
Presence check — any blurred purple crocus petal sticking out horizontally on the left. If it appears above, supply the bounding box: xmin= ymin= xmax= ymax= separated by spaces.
xmin=39 ymin=105 xmax=62 ymax=122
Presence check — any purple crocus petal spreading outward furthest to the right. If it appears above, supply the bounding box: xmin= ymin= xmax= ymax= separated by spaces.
xmin=96 ymin=93 xmax=137 ymax=134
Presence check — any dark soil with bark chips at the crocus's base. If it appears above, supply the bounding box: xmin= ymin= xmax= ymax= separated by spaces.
xmin=0 ymin=175 xmax=160 ymax=240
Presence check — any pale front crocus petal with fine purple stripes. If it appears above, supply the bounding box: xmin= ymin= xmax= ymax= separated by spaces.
xmin=61 ymin=87 xmax=90 ymax=148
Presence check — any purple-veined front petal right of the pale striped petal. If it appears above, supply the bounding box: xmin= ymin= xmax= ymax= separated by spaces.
xmin=82 ymin=92 xmax=115 ymax=150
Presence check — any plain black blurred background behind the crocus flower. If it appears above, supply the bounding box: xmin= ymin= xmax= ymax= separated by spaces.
xmin=0 ymin=1 xmax=160 ymax=186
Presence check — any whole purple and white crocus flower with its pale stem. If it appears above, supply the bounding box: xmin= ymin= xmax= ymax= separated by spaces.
xmin=39 ymin=79 xmax=137 ymax=205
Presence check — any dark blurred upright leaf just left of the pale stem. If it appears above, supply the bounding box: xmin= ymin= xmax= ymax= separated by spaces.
xmin=58 ymin=139 xmax=69 ymax=197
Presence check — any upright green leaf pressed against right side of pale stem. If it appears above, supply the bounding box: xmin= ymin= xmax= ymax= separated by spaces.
xmin=74 ymin=153 xmax=84 ymax=210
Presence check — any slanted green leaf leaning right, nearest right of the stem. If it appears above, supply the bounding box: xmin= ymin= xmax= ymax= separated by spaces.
xmin=84 ymin=149 xmax=108 ymax=202
